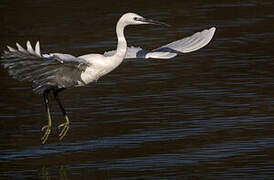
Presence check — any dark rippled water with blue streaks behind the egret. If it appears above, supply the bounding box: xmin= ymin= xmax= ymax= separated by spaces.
xmin=0 ymin=0 xmax=274 ymax=180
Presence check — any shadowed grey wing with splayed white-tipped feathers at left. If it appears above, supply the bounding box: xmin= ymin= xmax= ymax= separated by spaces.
xmin=1 ymin=41 xmax=89 ymax=94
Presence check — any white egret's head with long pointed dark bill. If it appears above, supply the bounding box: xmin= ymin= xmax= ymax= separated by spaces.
xmin=121 ymin=13 xmax=169 ymax=26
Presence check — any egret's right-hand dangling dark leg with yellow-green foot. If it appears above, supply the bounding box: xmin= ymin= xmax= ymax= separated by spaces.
xmin=54 ymin=90 xmax=69 ymax=140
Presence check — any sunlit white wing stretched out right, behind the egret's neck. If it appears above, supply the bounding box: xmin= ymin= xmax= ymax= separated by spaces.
xmin=104 ymin=27 xmax=216 ymax=59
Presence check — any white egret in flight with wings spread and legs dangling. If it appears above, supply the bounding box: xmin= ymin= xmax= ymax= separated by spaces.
xmin=1 ymin=13 xmax=215 ymax=144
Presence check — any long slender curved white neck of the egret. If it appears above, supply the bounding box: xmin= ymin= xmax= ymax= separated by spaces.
xmin=114 ymin=19 xmax=127 ymax=61
